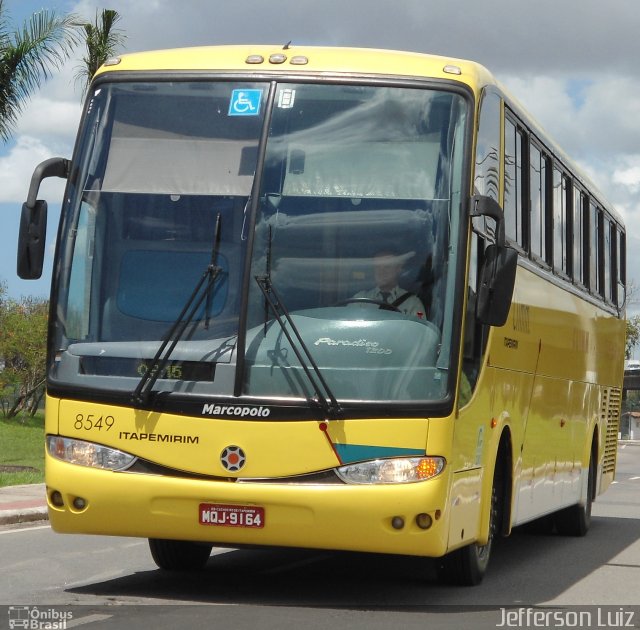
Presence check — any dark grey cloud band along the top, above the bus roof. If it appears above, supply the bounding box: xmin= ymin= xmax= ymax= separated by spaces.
xmin=73 ymin=0 xmax=640 ymax=76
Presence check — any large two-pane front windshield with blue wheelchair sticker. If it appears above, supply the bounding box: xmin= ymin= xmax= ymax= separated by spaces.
xmin=50 ymin=79 xmax=469 ymax=405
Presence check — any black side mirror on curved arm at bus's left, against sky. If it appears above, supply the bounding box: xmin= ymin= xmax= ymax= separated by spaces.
xmin=17 ymin=158 xmax=69 ymax=280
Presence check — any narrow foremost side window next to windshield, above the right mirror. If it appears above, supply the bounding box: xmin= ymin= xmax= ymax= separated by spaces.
xmin=474 ymin=92 xmax=501 ymax=201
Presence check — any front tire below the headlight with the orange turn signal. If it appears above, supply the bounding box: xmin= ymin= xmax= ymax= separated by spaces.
xmin=437 ymin=468 xmax=504 ymax=586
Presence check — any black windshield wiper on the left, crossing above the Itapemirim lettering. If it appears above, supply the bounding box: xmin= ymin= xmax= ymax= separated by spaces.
xmin=131 ymin=213 xmax=222 ymax=405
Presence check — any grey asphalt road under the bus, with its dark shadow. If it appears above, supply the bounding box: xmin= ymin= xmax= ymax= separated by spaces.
xmin=0 ymin=444 xmax=640 ymax=630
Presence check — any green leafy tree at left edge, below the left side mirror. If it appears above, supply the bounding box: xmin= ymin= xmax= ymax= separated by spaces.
xmin=0 ymin=284 xmax=49 ymax=418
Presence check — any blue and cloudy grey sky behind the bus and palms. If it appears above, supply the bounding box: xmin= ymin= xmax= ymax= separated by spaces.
xmin=0 ymin=0 xmax=640 ymax=330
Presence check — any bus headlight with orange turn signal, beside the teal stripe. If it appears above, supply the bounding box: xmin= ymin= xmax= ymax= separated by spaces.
xmin=336 ymin=457 xmax=445 ymax=484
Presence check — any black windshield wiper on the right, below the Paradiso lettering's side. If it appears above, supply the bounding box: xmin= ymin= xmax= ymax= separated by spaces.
xmin=255 ymin=275 xmax=342 ymax=419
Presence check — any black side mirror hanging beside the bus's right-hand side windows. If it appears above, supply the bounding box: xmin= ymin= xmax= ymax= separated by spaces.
xmin=476 ymin=245 xmax=518 ymax=326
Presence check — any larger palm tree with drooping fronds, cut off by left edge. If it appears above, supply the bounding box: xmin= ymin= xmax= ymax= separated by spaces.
xmin=0 ymin=0 xmax=79 ymax=142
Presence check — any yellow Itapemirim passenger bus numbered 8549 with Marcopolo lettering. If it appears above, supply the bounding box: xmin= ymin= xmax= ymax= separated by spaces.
xmin=18 ymin=46 xmax=625 ymax=584
